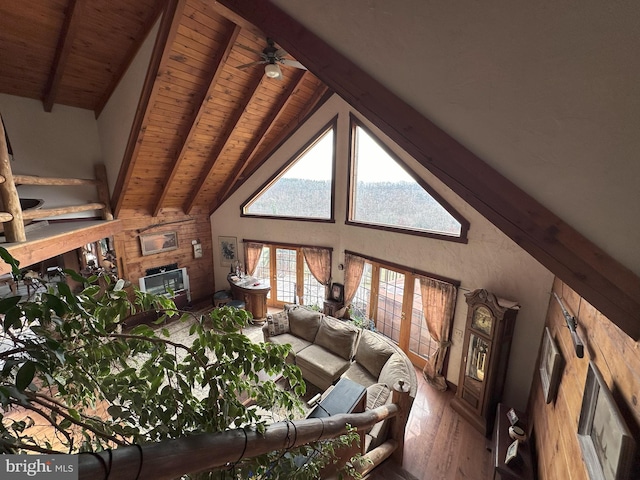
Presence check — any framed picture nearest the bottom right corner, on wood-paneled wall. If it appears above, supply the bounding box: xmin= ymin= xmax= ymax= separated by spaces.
xmin=578 ymin=362 xmax=636 ymax=480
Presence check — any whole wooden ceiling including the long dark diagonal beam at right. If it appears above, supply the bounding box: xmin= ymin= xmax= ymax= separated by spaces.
xmin=5 ymin=0 xmax=640 ymax=339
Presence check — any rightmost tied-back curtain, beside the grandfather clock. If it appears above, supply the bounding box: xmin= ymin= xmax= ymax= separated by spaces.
xmin=420 ymin=277 xmax=457 ymax=391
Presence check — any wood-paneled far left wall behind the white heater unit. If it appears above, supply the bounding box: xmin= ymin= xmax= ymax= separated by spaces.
xmin=114 ymin=212 xmax=213 ymax=301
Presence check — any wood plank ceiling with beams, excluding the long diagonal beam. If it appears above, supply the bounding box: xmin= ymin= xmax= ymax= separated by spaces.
xmin=0 ymin=0 xmax=327 ymax=216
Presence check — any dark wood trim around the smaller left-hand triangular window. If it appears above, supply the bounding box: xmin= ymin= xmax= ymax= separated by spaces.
xmin=240 ymin=115 xmax=338 ymax=223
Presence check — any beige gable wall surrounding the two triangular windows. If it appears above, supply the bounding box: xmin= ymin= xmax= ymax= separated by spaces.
xmin=211 ymin=96 xmax=553 ymax=409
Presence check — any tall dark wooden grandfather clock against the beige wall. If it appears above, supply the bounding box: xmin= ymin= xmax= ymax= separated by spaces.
xmin=451 ymin=289 xmax=520 ymax=436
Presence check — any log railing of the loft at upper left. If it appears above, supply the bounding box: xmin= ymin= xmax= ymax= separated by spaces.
xmin=0 ymin=118 xmax=113 ymax=243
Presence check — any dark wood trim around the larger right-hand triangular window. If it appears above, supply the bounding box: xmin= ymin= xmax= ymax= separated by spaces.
xmin=345 ymin=112 xmax=470 ymax=243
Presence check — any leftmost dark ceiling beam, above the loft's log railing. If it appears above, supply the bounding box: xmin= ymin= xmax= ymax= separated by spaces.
xmin=42 ymin=0 xmax=86 ymax=112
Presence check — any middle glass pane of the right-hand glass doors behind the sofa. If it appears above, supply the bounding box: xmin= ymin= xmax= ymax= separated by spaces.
xmin=376 ymin=268 xmax=404 ymax=343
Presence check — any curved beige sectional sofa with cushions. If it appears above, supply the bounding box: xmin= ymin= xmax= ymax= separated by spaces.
xmin=262 ymin=305 xmax=418 ymax=450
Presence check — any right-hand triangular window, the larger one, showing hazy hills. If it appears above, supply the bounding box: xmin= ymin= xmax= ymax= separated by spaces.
xmin=348 ymin=119 xmax=468 ymax=240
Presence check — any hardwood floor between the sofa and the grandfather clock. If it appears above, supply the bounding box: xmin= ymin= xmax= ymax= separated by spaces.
xmin=403 ymin=370 xmax=492 ymax=480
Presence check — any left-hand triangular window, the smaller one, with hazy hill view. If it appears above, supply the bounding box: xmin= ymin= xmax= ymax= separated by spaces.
xmin=242 ymin=122 xmax=336 ymax=221
